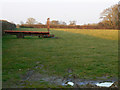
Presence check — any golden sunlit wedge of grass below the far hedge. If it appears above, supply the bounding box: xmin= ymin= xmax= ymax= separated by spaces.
xmin=55 ymin=29 xmax=118 ymax=40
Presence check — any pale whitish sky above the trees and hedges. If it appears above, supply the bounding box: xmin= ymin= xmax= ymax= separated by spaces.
xmin=0 ymin=0 xmax=119 ymax=25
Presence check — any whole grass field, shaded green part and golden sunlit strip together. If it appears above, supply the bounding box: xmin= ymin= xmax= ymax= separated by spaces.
xmin=2 ymin=28 xmax=118 ymax=87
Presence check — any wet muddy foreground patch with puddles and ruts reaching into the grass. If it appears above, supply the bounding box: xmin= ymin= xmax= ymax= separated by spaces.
xmin=20 ymin=62 xmax=118 ymax=88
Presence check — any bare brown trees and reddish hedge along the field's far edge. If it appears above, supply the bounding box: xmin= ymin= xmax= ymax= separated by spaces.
xmin=20 ymin=4 xmax=119 ymax=29
